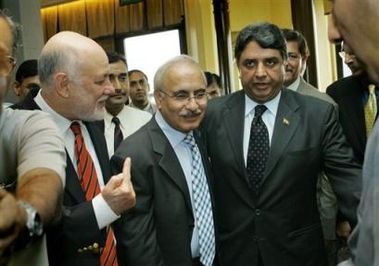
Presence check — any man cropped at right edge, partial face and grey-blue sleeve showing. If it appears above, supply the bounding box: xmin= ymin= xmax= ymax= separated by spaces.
xmin=325 ymin=0 xmax=379 ymax=266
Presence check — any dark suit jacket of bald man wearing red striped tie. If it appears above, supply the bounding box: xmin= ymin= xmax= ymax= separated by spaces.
xmin=12 ymin=94 xmax=111 ymax=266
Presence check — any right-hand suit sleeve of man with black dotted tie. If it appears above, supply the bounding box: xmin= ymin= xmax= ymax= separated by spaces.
xmin=322 ymin=105 xmax=362 ymax=227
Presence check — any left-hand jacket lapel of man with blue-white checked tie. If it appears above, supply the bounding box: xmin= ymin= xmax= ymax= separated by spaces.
xmin=147 ymin=119 xmax=192 ymax=210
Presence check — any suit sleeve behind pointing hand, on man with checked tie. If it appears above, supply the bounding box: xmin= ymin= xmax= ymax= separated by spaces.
xmin=111 ymin=154 xmax=163 ymax=266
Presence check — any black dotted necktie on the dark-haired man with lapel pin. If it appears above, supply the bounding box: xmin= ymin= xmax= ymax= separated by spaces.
xmin=246 ymin=105 xmax=269 ymax=196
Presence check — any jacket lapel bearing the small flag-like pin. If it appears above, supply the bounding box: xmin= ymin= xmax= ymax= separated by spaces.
xmin=262 ymin=89 xmax=300 ymax=182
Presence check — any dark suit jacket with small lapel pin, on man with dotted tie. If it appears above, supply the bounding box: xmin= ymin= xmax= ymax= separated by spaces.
xmin=203 ymin=89 xmax=361 ymax=266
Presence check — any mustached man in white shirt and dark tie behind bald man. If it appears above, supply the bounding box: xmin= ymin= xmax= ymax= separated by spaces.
xmin=101 ymin=52 xmax=151 ymax=157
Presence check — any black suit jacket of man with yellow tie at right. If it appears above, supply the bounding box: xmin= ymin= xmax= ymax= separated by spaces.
xmin=326 ymin=75 xmax=367 ymax=163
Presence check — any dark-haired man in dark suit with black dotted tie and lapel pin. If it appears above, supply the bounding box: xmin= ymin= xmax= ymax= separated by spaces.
xmin=203 ymin=23 xmax=361 ymax=266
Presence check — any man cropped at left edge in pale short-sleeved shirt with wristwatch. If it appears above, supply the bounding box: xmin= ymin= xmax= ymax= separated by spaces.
xmin=0 ymin=10 xmax=66 ymax=266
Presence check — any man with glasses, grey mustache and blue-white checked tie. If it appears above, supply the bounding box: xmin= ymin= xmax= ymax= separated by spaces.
xmin=111 ymin=55 xmax=215 ymax=266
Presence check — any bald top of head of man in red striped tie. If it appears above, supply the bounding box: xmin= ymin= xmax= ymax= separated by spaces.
xmin=38 ymin=31 xmax=108 ymax=88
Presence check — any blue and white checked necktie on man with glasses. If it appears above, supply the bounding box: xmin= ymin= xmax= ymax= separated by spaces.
xmin=183 ymin=134 xmax=215 ymax=266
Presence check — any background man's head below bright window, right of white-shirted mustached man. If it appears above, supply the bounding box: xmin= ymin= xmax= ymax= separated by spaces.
xmin=128 ymin=69 xmax=157 ymax=114
